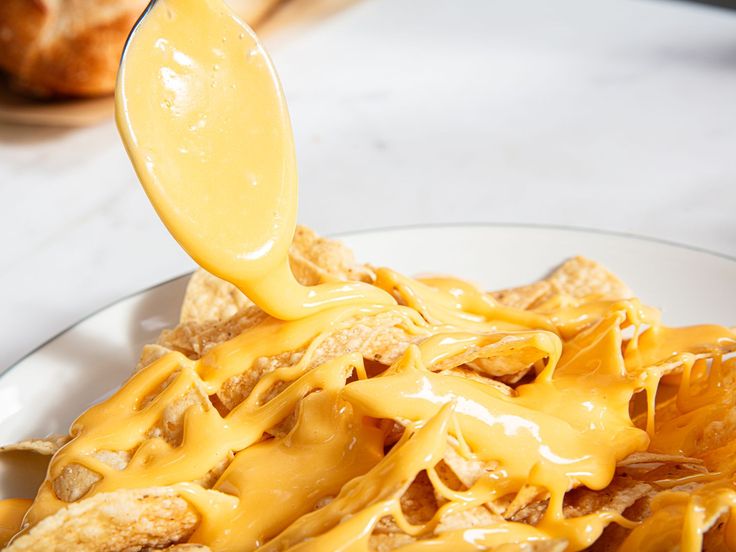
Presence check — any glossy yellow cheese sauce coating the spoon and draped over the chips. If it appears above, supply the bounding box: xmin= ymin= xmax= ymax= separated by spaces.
xmin=0 ymin=0 xmax=736 ymax=551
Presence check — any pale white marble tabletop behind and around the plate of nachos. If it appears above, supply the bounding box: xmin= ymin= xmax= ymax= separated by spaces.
xmin=0 ymin=0 xmax=736 ymax=370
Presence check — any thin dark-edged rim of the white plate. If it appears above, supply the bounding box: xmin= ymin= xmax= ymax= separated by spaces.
xmin=0 ymin=222 xmax=736 ymax=383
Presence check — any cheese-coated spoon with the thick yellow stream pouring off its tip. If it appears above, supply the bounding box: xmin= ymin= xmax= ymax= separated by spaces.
xmin=115 ymin=0 xmax=391 ymax=319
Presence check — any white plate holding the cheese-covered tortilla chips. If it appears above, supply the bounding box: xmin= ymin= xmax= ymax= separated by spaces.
xmin=0 ymin=225 xmax=736 ymax=498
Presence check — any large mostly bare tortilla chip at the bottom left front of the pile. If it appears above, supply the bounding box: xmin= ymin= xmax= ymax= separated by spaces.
xmin=7 ymin=487 xmax=199 ymax=552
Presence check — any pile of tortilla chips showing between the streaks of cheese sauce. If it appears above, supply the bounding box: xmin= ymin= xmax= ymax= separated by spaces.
xmin=0 ymin=228 xmax=736 ymax=552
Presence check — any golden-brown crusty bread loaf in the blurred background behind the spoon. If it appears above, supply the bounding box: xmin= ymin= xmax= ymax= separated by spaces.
xmin=0 ymin=0 xmax=277 ymax=97
